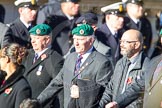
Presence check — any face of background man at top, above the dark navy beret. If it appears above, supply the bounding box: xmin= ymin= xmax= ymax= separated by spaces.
xmin=67 ymin=2 xmax=79 ymax=16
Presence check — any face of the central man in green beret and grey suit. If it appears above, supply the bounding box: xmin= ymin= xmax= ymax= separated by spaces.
xmin=73 ymin=35 xmax=93 ymax=54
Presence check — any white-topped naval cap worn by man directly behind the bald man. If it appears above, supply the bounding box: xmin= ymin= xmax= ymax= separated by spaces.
xmin=101 ymin=2 xmax=125 ymax=16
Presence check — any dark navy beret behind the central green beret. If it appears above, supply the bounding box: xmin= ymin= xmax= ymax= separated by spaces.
xmin=75 ymin=12 xmax=98 ymax=25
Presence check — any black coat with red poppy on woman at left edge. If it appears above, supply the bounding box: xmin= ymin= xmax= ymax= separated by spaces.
xmin=0 ymin=67 xmax=31 ymax=108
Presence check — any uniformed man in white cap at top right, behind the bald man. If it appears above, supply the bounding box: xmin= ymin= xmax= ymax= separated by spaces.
xmin=124 ymin=0 xmax=152 ymax=56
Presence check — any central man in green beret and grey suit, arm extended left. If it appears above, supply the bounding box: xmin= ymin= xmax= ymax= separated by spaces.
xmin=38 ymin=24 xmax=112 ymax=108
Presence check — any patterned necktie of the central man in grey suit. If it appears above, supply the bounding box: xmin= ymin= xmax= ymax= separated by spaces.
xmin=75 ymin=55 xmax=83 ymax=79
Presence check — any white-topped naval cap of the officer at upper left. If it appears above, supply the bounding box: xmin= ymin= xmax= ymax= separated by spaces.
xmin=14 ymin=0 xmax=39 ymax=9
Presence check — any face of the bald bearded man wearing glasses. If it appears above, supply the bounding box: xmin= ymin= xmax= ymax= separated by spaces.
xmin=120 ymin=33 xmax=139 ymax=58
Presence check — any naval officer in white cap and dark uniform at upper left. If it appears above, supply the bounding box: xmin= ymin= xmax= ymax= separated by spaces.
xmin=7 ymin=0 xmax=38 ymax=48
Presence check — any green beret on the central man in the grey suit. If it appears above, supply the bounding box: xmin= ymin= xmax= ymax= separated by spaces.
xmin=72 ymin=24 xmax=94 ymax=36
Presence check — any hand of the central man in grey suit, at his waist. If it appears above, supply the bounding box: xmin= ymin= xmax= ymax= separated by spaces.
xmin=70 ymin=85 xmax=79 ymax=98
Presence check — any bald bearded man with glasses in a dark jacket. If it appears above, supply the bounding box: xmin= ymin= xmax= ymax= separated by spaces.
xmin=100 ymin=29 xmax=149 ymax=108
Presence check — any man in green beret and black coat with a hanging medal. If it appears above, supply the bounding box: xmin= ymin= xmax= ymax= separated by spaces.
xmin=24 ymin=24 xmax=63 ymax=108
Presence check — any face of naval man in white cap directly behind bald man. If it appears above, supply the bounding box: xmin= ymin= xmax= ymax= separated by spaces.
xmin=106 ymin=15 xmax=124 ymax=31
